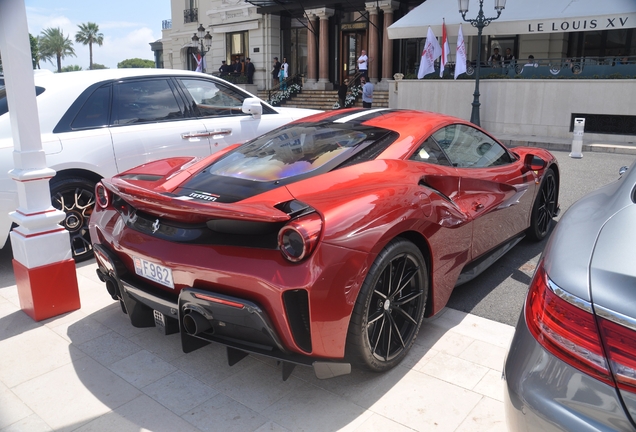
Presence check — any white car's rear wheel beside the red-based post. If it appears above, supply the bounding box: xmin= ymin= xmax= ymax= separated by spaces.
xmin=51 ymin=178 xmax=95 ymax=262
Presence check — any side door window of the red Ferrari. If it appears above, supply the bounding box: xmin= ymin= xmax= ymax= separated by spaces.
xmin=433 ymin=125 xmax=512 ymax=168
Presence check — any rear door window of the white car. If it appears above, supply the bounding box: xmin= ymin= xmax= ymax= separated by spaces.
xmin=113 ymin=79 xmax=183 ymax=125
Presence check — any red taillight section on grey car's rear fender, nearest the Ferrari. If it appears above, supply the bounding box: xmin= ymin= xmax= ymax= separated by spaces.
xmin=525 ymin=262 xmax=615 ymax=386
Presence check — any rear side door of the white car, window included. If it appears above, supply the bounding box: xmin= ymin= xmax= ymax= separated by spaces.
xmin=110 ymin=77 xmax=211 ymax=171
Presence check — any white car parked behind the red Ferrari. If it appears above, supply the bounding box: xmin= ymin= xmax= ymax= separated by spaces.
xmin=0 ymin=69 xmax=319 ymax=260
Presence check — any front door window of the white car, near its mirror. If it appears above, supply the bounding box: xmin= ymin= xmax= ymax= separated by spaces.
xmin=181 ymin=79 xmax=247 ymax=117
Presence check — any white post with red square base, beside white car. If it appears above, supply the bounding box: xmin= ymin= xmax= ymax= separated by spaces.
xmin=0 ymin=0 xmax=80 ymax=321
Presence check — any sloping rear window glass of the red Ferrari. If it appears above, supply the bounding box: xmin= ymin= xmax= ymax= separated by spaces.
xmin=208 ymin=123 xmax=389 ymax=181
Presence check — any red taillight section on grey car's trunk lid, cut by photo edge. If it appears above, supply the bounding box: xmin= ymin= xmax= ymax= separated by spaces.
xmin=596 ymin=307 xmax=636 ymax=393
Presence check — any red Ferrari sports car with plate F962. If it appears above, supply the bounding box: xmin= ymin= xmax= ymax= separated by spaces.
xmin=90 ymin=109 xmax=559 ymax=379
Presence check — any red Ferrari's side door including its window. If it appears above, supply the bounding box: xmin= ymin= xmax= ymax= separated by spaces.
xmin=433 ymin=124 xmax=535 ymax=259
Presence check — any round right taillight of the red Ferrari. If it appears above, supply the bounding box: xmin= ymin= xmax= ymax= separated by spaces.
xmin=278 ymin=213 xmax=322 ymax=262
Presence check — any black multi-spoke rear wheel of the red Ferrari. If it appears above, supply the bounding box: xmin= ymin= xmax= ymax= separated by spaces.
xmin=345 ymin=239 xmax=429 ymax=372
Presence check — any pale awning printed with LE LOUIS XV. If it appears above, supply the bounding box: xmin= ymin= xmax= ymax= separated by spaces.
xmin=388 ymin=0 xmax=636 ymax=39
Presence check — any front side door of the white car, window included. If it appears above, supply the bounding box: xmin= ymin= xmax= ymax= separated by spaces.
xmin=179 ymin=77 xmax=291 ymax=152
